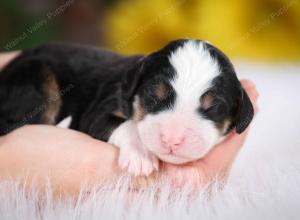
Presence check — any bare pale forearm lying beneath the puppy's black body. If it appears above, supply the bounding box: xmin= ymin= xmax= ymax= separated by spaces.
xmin=0 ymin=126 xmax=120 ymax=194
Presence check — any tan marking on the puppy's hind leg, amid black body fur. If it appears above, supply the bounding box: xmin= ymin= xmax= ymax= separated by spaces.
xmin=43 ymin=72 xmax=62 ymax=124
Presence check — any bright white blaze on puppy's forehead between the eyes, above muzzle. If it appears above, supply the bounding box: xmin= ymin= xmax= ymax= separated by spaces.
xmin=169 ymin=40 xmax=220 ymax=101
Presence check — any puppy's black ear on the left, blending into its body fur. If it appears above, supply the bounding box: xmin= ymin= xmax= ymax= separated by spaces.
xmin=122 ymin=58 xmax=144 ymax=101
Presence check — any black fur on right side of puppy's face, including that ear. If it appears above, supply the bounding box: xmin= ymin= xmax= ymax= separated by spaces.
xmin=203 ymin=41 xmax=254 ymax=134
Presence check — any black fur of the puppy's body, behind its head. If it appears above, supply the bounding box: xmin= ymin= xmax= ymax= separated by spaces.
xmin=0 ymin=43 xmax=141 ymax=140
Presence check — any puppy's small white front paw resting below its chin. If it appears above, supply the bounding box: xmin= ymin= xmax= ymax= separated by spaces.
xmin=119 ymin=148 xmax=159 ymax=176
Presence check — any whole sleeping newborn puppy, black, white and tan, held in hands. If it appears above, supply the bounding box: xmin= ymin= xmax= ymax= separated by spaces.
xmin=0 ymin=39 xmax=253 ymax=175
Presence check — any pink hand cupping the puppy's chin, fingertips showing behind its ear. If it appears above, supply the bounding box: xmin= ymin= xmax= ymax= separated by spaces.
xmin=163 ymin=80 xmax=258 ymax=188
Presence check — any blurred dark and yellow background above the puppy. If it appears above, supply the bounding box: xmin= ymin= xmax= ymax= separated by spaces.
xmin=0 ymin=0 xmax=300 ymax=61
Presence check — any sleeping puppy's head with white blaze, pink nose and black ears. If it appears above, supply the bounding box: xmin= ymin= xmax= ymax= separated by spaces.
xmin=123 ymin=40 xmax=253 ymax=163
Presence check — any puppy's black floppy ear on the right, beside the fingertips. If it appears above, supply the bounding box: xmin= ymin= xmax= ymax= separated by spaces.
xmin=235 ymin=88 xmax=254 ymax=134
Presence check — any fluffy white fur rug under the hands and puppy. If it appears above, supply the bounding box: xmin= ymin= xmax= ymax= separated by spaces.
xmin=0 ymin=64 xmax=300 ymax=220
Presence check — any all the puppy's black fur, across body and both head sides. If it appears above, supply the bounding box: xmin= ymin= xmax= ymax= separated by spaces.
xmin=0 ymin=40 xmax=253 ymax=141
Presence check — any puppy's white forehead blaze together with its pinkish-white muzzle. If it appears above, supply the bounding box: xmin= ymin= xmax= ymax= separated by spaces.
xmin=138 ymin=40 xmax=224 ymax=163
